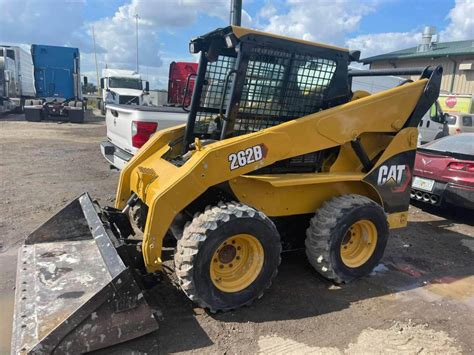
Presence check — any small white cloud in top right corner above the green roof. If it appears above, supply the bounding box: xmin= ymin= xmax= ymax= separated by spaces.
xmin=440 ymin=0 xmax=474 ymax=41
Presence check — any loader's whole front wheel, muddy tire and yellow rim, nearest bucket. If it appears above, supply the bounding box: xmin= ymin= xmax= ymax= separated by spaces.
xmin=175 ymin=203 xmax=281 ymax=312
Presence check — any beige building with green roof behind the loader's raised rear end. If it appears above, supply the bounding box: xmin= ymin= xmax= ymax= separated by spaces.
xmin=361 ymin=27 xmax=474 ymax=95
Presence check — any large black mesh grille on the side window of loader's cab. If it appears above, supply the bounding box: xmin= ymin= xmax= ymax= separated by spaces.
xmin=232 ymin=48 xmax=336 ymax=135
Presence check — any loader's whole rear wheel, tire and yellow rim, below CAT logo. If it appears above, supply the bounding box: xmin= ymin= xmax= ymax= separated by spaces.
xmin=306 ymin=195 xmax=389 ymax=283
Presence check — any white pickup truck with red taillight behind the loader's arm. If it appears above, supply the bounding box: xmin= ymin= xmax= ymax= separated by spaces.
xmin=100 ymin=104 xmax=188 ymax=170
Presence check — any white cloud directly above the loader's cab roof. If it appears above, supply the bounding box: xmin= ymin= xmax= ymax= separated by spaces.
xmin=259 ymin=0 xmax=376 ymax=44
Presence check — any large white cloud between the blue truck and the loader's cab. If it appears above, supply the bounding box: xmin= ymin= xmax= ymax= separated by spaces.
xmin=86 ymin=0 xmax=234 ymax=88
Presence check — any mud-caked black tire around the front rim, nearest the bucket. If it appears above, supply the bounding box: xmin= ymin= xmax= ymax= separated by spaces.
xmin=174 ymin=202 xmax=281 ymax=312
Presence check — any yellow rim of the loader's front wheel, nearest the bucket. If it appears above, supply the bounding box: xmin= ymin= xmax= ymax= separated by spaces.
xmin=210 ymin=234 xmax=264 ymax=293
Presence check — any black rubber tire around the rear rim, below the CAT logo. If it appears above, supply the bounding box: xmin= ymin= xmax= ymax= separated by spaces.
xmin=305 ymin=195 xmax=389 ymax=283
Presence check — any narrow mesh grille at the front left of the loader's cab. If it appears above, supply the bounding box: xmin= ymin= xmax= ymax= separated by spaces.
xmin=194 ymin=55 xmax=235 ymax=135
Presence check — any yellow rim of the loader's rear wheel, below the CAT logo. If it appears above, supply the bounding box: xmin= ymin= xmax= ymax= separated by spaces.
xmin=341 ymin=219 xmax=377 ymax=268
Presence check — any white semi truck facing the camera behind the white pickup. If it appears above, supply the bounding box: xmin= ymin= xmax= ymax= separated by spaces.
xmin=100 ymin=68 xmax=151 ymax=115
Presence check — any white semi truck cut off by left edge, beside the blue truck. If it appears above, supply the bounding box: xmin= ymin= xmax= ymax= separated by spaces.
xmin=0 ymin=45 xmax=36 ymax=113
